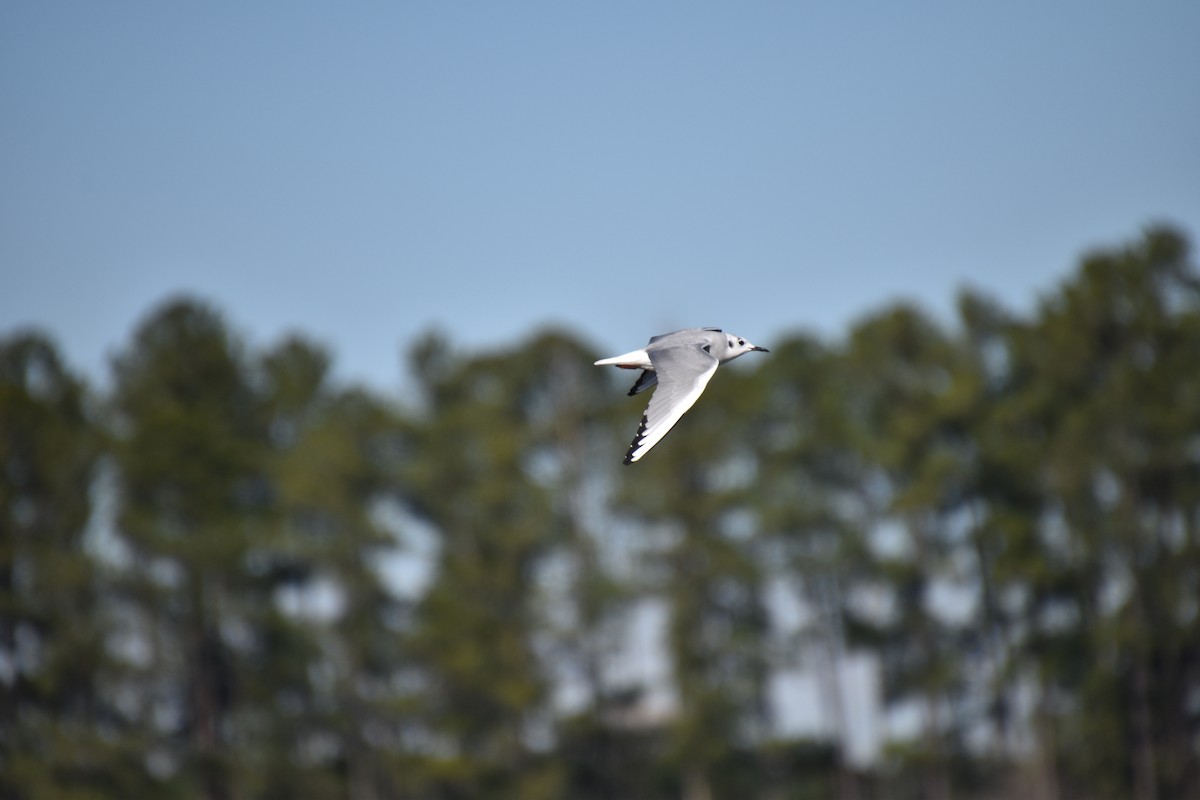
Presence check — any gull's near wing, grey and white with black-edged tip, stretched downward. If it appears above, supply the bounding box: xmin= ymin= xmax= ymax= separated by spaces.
xmin=625 ymin=344 xmax=720 ymax=464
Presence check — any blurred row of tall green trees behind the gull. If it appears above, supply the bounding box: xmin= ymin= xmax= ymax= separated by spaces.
xmin=7 ymin=227 xmax=1200 ymax=800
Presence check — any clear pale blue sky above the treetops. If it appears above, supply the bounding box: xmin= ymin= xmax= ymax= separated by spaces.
xmin=0 ymin=0 xmax=1200 ymax=389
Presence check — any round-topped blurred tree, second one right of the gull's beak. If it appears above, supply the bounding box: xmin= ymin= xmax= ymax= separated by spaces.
xmin=842 ymin=306 xmax=976 ymax=800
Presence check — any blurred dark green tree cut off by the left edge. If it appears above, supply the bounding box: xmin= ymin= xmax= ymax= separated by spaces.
xmin=0 ymin=333 xmax=149 ymax=800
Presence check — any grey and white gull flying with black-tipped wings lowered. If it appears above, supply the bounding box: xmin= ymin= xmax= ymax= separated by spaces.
xmin=595 ymin=327 xmax=769 ymax=464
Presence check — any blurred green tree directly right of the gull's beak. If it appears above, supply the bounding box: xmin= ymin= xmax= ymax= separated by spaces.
xmin=751 ymin=336 xmax=875 ymax=800
